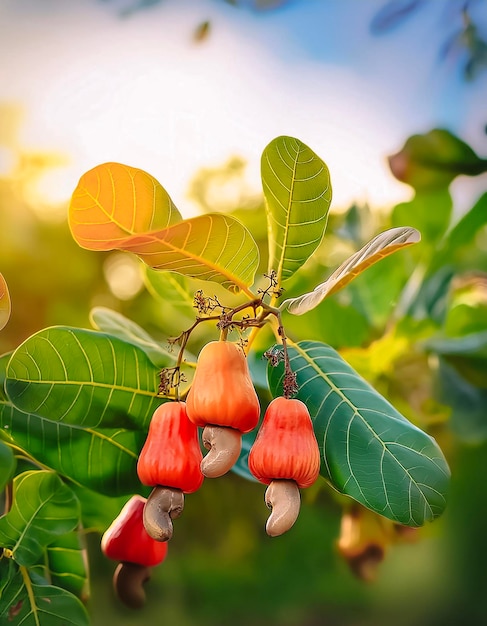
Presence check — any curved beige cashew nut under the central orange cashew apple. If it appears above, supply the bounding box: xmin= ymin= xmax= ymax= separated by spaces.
xmin=201 ymin=424 xmax=242 ymax=478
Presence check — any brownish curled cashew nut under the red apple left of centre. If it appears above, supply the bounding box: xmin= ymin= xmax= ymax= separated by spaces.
xmin=143 ymin=486 xmax=184 ymax=541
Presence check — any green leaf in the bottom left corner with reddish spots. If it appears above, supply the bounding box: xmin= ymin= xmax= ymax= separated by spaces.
xmin=0 ymin=558 xmax=89 ymax=626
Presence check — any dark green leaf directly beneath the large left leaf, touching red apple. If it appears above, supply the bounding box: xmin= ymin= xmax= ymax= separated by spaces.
xmin=0 ymin=402 xmax=147 ymax=496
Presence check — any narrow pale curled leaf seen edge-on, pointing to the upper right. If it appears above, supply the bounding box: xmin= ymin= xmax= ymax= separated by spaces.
xmin=281 ymin=227 xmax=421 ymax=315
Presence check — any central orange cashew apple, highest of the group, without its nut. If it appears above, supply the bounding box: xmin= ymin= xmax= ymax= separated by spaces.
xmin=186 ymin=341 xmax=260 ymax=433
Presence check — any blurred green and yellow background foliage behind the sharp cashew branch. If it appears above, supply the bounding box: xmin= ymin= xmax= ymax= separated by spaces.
xmin=0 ymin=113 xmax=487 ymax=626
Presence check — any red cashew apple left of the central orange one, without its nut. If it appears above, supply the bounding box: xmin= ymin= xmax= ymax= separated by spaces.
xmin=137 ymin=402 xmax=204 ymax=493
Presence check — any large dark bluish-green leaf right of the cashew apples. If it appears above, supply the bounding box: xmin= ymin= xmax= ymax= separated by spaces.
xmin=268 ymin=341 xmax=450 ymax=526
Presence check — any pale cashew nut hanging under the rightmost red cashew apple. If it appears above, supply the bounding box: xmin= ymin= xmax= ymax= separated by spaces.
xmin=265 ymin=480 xmax=301 ymax=537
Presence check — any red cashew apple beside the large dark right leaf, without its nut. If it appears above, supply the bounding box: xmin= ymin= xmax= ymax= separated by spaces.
xmin=248 ymin=397 xmax=321 ymax=488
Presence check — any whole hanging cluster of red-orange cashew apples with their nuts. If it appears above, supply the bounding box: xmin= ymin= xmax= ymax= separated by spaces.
xmin=101 ymin=341 xmax=320 ymax=604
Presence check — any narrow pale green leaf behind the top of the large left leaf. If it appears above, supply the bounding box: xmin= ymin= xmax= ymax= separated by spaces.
xmin=90 ymin=306 xmax=177 ymax=369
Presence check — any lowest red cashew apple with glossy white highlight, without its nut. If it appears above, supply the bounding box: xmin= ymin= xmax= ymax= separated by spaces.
xmin=101 ymin=496 xmax=167 ymax=567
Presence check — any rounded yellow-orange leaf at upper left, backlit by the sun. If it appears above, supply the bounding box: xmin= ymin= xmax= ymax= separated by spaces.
xmin=69 ymin=163 xmax=182 ymax=250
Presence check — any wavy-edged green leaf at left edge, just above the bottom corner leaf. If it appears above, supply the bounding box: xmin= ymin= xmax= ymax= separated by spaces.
xmin=0 ymin=471 xmax=80 ymax=566
